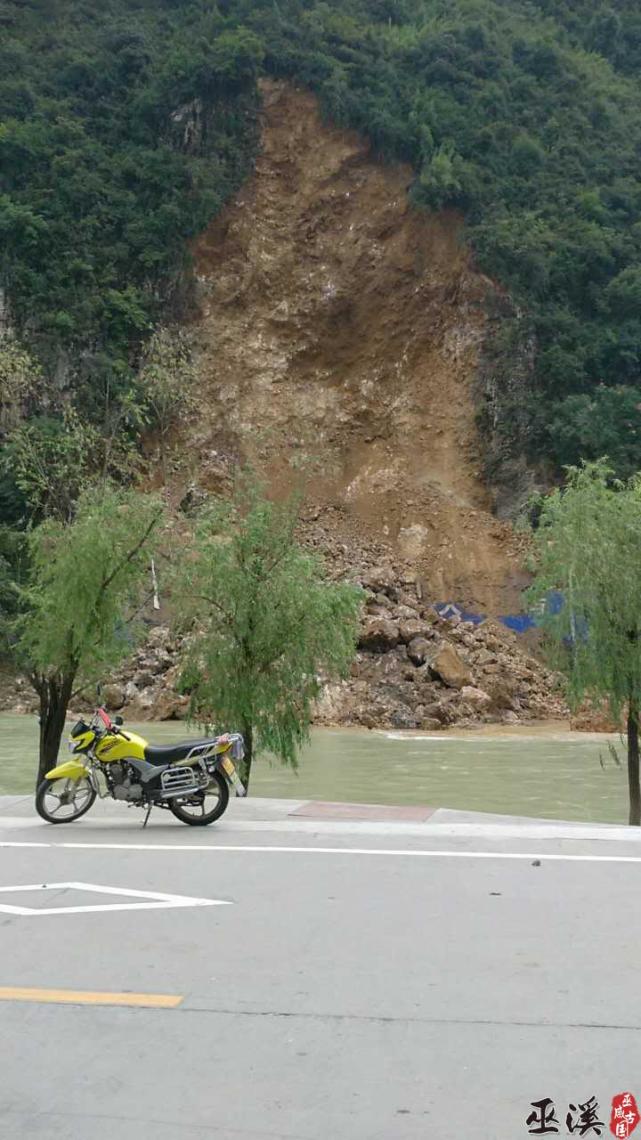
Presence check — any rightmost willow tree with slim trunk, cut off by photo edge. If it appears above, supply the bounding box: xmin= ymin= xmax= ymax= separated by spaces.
xmin=530 ymin=459 xmax=641 ymax=827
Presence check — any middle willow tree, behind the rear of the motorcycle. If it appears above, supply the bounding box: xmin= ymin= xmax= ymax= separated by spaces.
xmin=173 ymin=479 xmax=362 ymax=788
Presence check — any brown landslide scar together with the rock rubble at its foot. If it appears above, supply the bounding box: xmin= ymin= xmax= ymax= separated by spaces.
xmin=0 ymin=82 xmax=567 ymax=730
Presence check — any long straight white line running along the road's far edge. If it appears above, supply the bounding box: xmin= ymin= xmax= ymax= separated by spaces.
xmin=0 ymin=841 xmax=641 ymax=861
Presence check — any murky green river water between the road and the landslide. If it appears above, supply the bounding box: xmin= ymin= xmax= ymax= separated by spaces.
xmin=0 ymin=714 xmax=627 ymax=823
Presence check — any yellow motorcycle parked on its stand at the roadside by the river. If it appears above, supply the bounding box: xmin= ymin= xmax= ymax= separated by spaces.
xmin=35 ymin=708 xmax=245 ymax=827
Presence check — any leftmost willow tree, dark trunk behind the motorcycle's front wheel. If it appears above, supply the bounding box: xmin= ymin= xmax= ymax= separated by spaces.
xmin=14 ymin=485 xmax=162 ymax=783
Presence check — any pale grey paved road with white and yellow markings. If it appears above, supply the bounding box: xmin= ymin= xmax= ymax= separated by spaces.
xmin=0 ymin=801 xmax=641 ymax=1140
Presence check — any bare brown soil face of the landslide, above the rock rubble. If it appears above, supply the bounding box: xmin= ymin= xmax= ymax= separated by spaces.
xmin=177 ymin=82 xmax=524 ymax=612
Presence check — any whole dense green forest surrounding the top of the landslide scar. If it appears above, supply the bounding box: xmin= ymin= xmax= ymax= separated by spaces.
xmin=0 ymin=0 xmax=641 ymax=515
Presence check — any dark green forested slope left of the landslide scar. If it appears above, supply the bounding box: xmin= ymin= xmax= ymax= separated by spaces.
xmin=0 ymin=0 xmax=261 ymax=522
